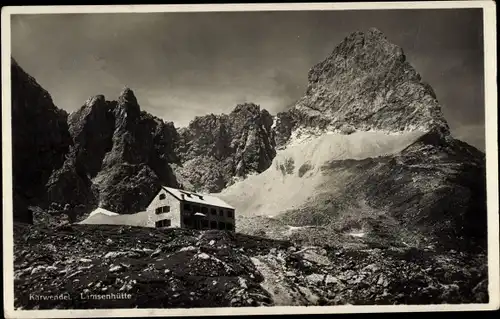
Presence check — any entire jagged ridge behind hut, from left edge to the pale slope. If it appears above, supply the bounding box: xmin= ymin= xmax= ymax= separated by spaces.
xmin=12 ymin=58 xmax=275 ymax=222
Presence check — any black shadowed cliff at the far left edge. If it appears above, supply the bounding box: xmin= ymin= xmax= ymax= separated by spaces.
xmin=11 ymin=59 xmax=72 ymax=222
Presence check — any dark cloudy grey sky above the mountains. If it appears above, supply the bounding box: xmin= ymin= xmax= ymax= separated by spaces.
xmin=12 ymin=9 xmax=484 ymax=150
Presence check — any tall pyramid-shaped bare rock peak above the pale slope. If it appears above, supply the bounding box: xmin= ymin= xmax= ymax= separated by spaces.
xmin=276 ymin=29 xmax=449 ymax=146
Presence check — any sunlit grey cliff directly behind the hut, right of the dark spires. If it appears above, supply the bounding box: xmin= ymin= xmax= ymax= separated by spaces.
xmin=175 ymin=104 xmax=276 ymax=192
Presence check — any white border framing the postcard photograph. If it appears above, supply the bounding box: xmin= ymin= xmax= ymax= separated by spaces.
xmin=2 ymin=1 xmax=500 ymax=318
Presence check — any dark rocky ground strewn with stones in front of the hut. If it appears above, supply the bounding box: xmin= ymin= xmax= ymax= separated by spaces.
xmin=14 ymin=225 xmax=488 ymax=309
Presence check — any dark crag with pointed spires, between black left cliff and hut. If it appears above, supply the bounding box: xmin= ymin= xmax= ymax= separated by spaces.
xmin=49 ymin=88 xmax=178 ymax=214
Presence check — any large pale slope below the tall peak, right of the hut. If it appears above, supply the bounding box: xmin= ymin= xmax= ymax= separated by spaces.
xmin=217 ymin=130 xmax=424 ymax=217
